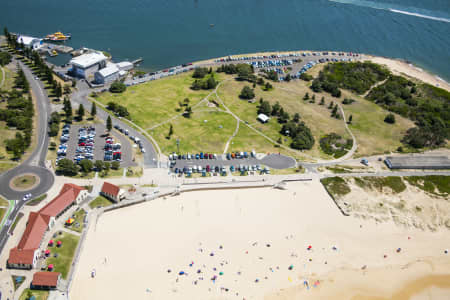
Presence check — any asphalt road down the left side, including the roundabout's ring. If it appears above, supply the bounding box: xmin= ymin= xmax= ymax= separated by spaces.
xmin=0 ymin=61 xmax=55 ymax=252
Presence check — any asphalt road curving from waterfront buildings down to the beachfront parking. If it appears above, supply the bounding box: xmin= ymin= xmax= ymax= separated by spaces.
xmin=72 ymin=81 xmax=158 ymax=168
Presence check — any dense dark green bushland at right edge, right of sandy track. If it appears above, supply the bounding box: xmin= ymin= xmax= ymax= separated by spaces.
xmin=366 ymin=75 xmax=450 ymax=148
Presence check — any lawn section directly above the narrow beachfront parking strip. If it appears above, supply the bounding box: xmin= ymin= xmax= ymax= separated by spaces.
xmin=150 ymin=111 xmax=236 ymax=154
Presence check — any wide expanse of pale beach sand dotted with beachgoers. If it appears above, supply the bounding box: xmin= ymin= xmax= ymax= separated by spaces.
xmin=70 ymin=181 xmax=450 ymax=300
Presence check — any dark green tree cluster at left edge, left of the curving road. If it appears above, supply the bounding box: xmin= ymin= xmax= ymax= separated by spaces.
xmin=0 ymin=67 xmax=34 ymax=159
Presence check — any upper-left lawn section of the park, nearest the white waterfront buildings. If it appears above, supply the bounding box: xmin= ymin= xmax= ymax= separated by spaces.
xmin=96 ymin=72 xmax=214 ymax=129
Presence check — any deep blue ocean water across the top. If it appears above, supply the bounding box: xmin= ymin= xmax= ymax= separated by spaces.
xmin=0 ymin=0 xmax=450 ymax=81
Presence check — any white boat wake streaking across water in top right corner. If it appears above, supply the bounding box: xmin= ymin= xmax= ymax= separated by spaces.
xmin=328 ymin=0 xmax=450 ymax=23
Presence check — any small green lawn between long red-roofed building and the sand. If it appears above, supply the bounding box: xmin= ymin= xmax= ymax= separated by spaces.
xmin=46 ymin=232 xmax=80 ymax=279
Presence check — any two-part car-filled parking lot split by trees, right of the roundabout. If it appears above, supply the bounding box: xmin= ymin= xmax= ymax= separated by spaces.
xmin=59 ymin=124 xmax=137 ymax=167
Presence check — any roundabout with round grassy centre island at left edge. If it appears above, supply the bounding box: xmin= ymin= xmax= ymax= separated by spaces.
xmin=0 ymin=165 xmax=55 ymax=200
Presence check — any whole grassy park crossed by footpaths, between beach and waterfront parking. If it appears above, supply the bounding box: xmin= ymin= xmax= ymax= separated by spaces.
xmin=96 ymin=66 xmax=428 ymax=159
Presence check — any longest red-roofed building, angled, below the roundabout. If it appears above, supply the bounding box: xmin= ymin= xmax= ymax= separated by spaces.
xmin=6 ymin=183 xmax=87 ymax=269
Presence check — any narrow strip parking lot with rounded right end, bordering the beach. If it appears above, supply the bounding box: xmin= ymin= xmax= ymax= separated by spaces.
xmin=171 ymin=152 xmax=295 ymax=173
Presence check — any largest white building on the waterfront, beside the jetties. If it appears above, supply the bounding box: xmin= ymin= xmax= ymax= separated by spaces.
xmin=70 ymin=52 xmax=107 ymax=80
